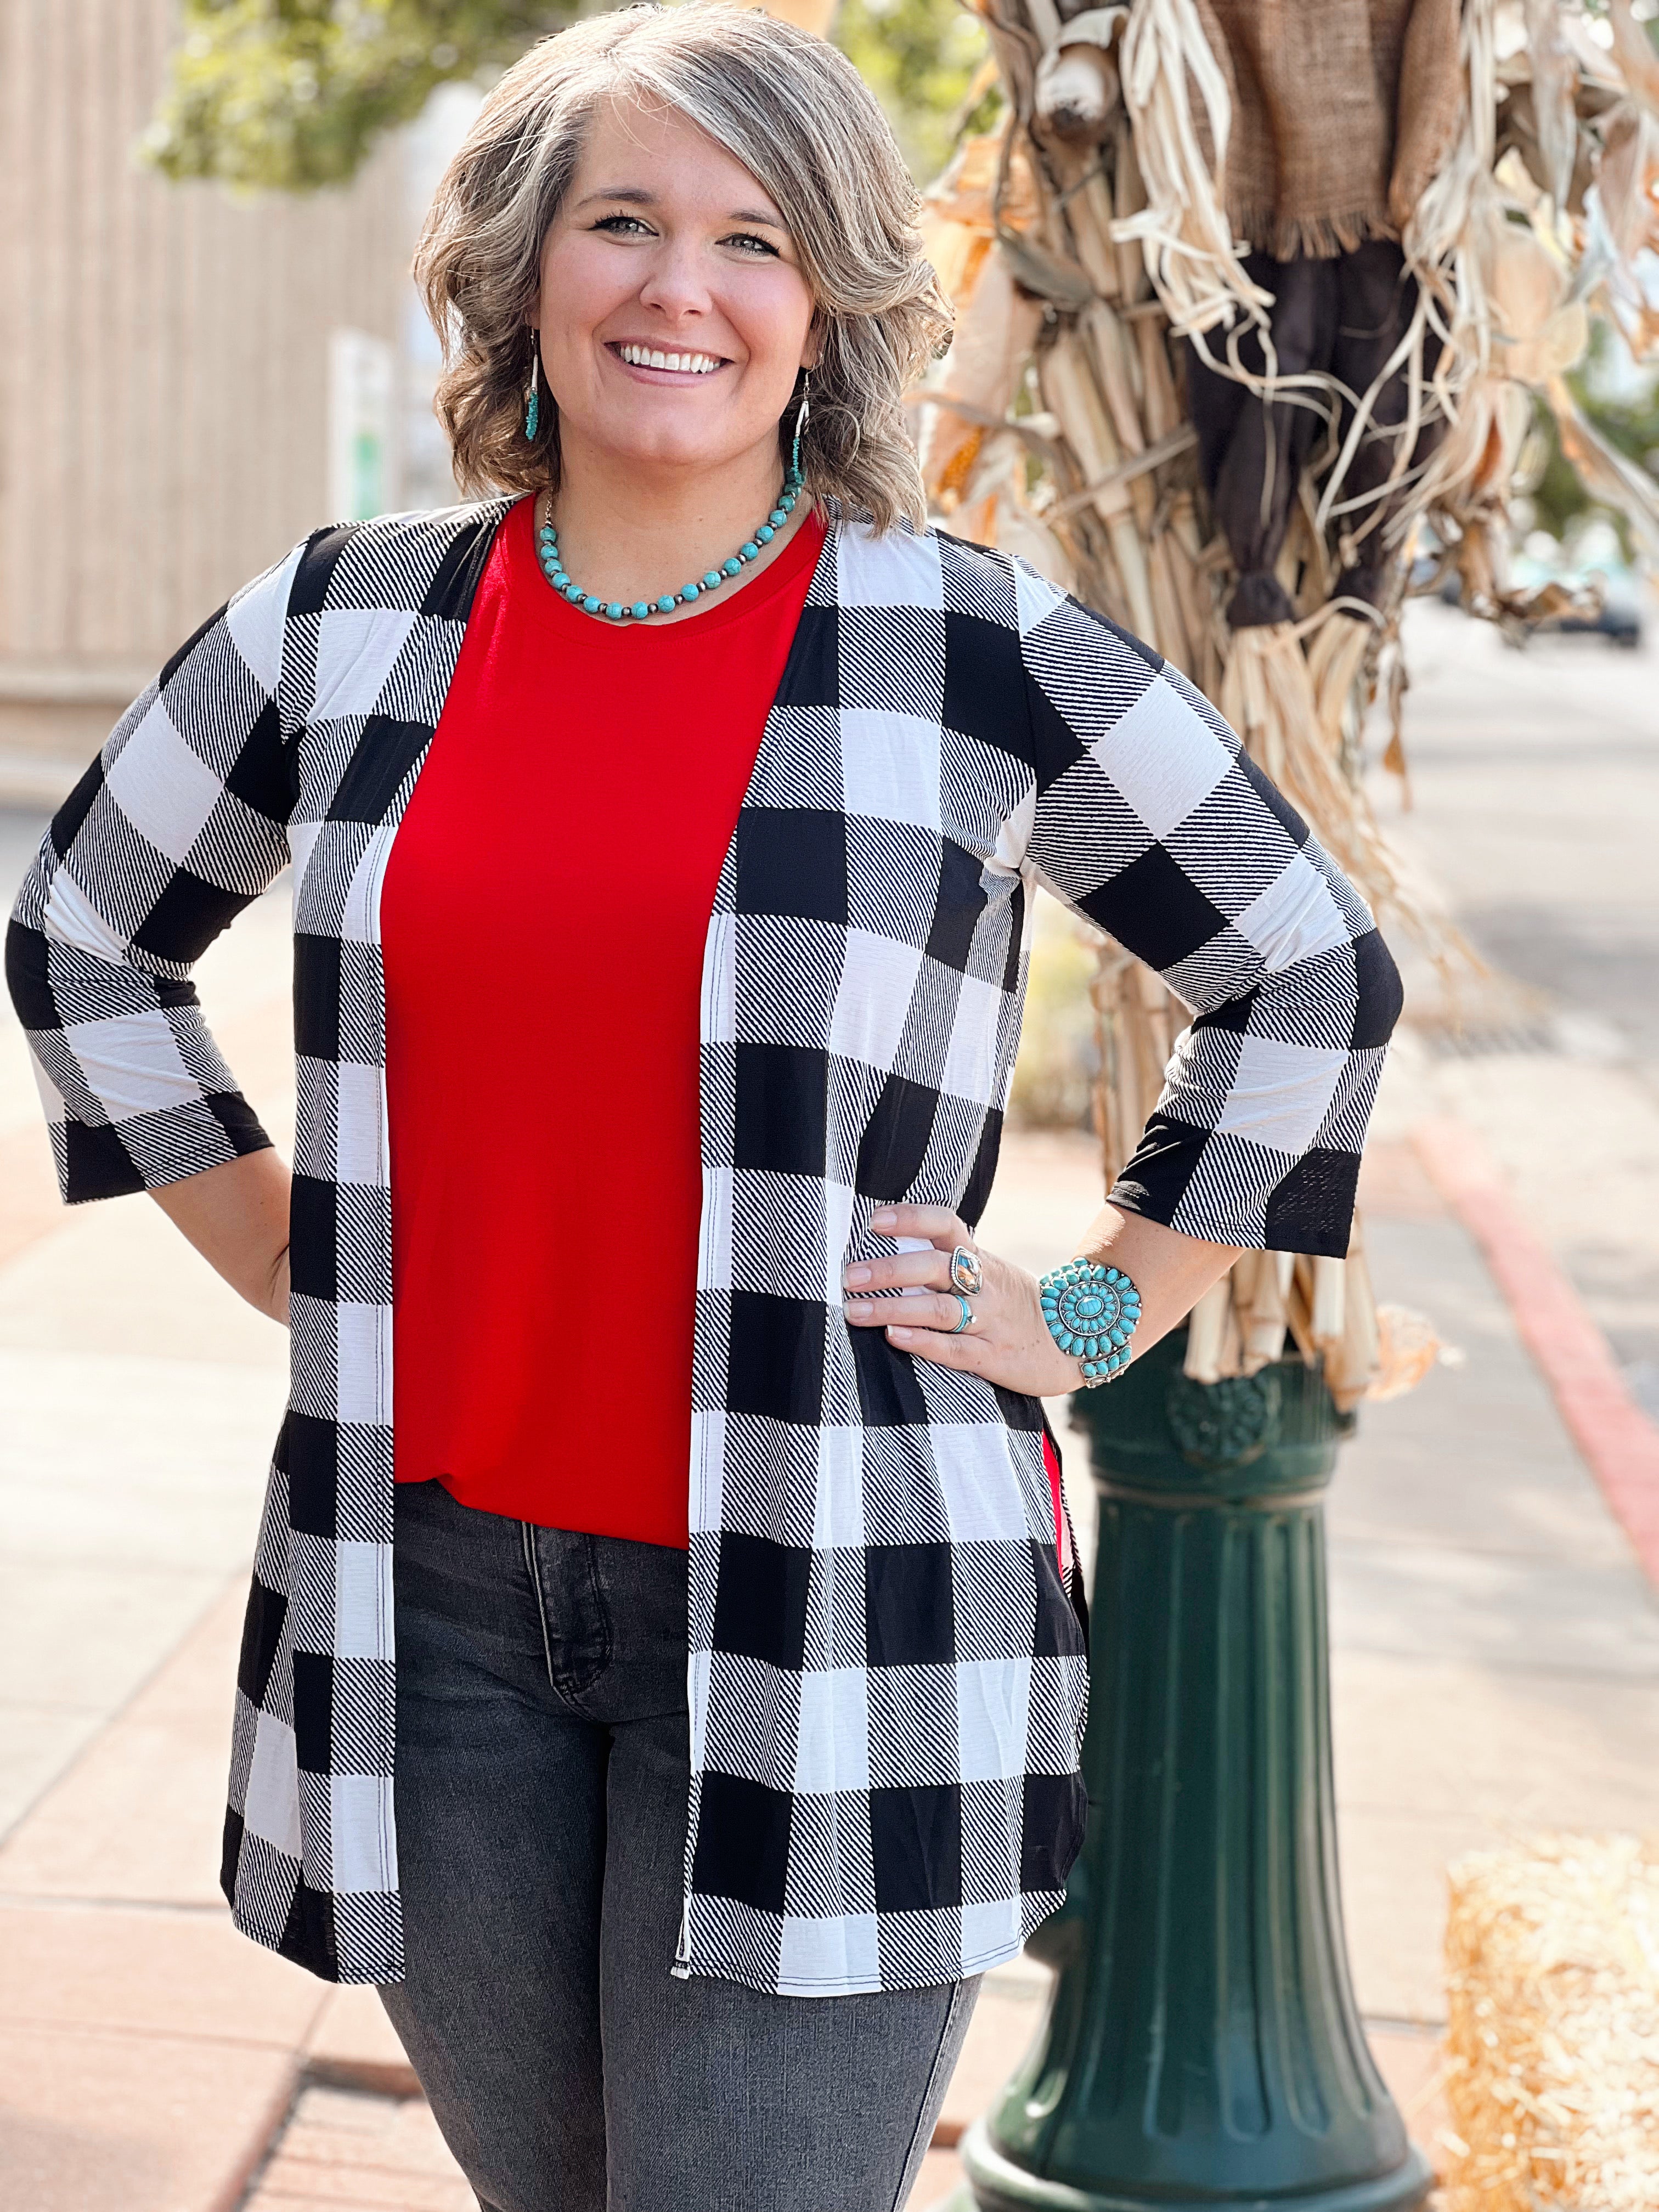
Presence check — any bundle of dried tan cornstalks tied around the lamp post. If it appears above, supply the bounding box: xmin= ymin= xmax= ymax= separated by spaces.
xmin=918 ymin=0 xmax=1659 ymax=1404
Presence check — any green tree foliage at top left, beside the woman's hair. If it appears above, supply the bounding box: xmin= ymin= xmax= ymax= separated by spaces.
xmin=144 ymin=0 xmax=575 ymax=193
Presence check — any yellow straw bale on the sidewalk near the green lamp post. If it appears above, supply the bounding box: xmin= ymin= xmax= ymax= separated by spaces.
xmin=1444 ymin=1836 xmax=1659 ymax=2212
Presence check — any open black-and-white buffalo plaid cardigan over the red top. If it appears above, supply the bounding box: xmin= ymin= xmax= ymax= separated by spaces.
xmin=9 ymin=502 xmax=1398 ymax=1995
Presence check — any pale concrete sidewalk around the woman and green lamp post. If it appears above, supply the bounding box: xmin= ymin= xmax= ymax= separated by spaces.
xmin=0 ymin=800 xmax=1659 ymax=2212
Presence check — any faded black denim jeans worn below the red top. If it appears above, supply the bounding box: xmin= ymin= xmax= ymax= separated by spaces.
xmin=381 ymin=1482 xmax=978 ymax=2212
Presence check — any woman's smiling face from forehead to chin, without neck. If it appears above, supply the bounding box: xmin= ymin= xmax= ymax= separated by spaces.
xmin=533 ymin=104 xmax=816 ymax=484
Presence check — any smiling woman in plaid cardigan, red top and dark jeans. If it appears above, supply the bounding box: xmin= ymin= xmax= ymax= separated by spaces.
xmin=9 ymin=7 xmax=1398 ymax=2212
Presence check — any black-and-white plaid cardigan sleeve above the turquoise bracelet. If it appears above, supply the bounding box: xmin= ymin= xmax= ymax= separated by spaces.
xmin=1024 ymin=600 xmax=1400 ymax=1259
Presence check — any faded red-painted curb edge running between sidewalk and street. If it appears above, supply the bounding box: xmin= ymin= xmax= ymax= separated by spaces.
xmin=1411 ymin=1117 xmax=1659 ymax=1588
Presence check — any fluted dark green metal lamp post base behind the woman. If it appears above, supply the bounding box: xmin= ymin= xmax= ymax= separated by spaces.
xmin=953 ymin=1331 xmax=1431 ymax=2212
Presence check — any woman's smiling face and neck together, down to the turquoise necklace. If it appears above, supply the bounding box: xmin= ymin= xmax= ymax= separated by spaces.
xmin=517 ymin=95 xmax=823 ymax=624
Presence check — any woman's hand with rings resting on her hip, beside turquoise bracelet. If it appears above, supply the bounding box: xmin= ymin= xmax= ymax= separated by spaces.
xmin=840 ymin=1205 xmax=1082 ymax=1398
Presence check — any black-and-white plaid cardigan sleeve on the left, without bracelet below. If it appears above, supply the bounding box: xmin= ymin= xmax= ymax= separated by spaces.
xmin=7 ymin=553 xmax=298 ymax=1203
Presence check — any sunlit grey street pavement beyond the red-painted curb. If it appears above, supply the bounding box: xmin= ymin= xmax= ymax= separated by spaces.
xmin=1372 ymin=600 xmax=1659 ymax=1420
